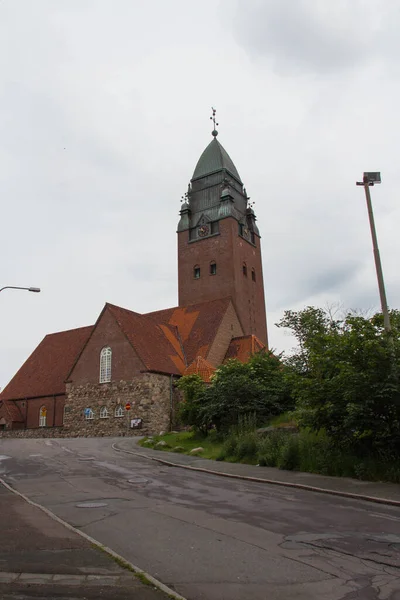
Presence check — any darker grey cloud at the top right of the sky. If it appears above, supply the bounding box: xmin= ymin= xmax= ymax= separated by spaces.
xmin=234 ymin=0 xmax=388 ymax=75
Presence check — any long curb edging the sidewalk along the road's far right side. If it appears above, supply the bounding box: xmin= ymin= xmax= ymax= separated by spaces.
xmin=112 ymin=443 xmax=400 ymax=507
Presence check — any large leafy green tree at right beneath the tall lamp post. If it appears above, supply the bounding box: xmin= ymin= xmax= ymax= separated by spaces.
xmin=278 ymin=307 xmax=400 ymax=455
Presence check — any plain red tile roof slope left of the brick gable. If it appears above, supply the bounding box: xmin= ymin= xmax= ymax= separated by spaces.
xmin=0 ymin=326 xmax=93 ymax=400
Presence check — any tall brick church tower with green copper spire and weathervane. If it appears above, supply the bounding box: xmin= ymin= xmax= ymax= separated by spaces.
xmin=178 ymin=110 xmax=268 ymax=345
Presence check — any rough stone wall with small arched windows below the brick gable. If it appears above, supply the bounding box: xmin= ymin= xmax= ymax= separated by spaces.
xmin=64 ymin=373 xmax=179 ymax=437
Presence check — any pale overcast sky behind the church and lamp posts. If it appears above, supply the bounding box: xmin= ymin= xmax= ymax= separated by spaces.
xmin=0 ymin=0 xmax=400 ymax=387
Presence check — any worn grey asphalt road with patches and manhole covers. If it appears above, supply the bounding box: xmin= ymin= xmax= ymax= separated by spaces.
xmin=0 ymin=438 xmax=400 ymax=600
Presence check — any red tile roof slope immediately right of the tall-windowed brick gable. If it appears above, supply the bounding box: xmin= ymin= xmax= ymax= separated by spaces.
xmin=106 ymin=304 xmax=186 ymax=375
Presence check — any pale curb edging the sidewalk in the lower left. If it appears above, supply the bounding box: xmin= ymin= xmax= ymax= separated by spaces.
xmin=0 ymin=478 xmax=187 ymax=600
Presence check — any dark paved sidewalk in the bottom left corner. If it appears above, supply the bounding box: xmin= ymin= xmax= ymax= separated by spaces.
xmin=0 ymin=484 xmax=167 ymax=600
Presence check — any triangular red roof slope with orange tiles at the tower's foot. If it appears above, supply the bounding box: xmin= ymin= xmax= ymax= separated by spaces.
xmin=144 ymin=298 xmax=231 ymax=365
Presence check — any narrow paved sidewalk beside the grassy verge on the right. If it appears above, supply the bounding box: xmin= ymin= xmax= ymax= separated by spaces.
xmin=116 ymin=438 xmax=400 ymax=502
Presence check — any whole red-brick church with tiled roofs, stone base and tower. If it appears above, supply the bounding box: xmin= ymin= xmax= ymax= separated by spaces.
xmin=0 ymin=123 xmax=268 ymax=437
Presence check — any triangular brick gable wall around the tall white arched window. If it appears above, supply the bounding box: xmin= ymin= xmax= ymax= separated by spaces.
xmin=70 ymin=308 xmax=145 ymax=385
